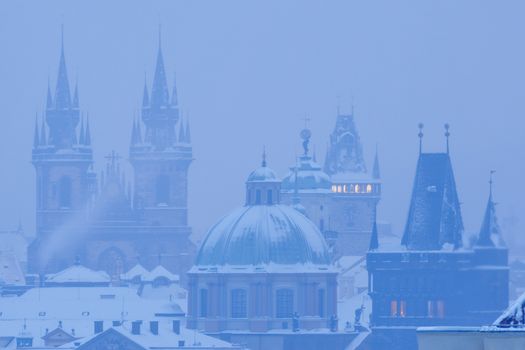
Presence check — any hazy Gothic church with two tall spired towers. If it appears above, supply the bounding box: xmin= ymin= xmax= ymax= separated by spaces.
xmin=28 ymin=33 xmax=195 ymax=279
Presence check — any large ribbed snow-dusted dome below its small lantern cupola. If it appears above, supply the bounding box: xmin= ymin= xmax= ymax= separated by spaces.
xmin=196 ymin=205 xmax=330 ymax=268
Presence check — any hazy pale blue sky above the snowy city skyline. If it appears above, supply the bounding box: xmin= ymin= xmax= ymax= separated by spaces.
xmin=0 ymin=0 xmax=525 ymax=252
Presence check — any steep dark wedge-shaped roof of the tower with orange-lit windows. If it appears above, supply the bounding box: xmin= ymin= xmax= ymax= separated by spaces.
xmin=401 ymin=153 xmax=463 ymax=250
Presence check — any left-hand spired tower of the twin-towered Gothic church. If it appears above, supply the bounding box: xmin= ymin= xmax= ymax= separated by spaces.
xmin=28 ymin=30 xmax=96 ymax=272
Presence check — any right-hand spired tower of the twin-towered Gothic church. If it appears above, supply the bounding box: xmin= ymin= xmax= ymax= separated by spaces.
xmin=130 ymin=32 xmax=195 ymax=272
